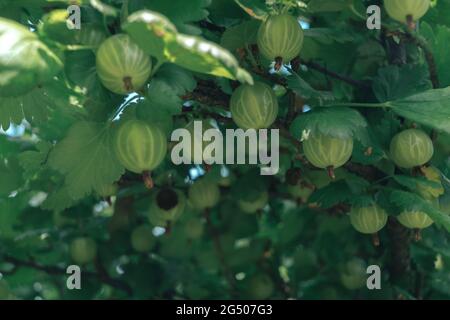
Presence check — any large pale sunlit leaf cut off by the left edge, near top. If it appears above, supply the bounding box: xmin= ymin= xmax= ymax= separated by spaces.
xmin=0 ymin=17 xmax=62 ymax=96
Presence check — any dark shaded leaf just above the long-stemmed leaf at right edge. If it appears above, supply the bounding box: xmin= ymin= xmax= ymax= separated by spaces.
xmin=372 ymin=64 xmax=432 ymax=102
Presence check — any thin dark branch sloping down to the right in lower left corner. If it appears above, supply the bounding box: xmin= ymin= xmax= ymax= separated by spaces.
xmin=2 ymin=254 xmax=133 ymax=295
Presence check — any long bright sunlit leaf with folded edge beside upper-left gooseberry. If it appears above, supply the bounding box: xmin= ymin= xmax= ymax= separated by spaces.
xmin=123 ymin=11 xmax=253 ymax=84
